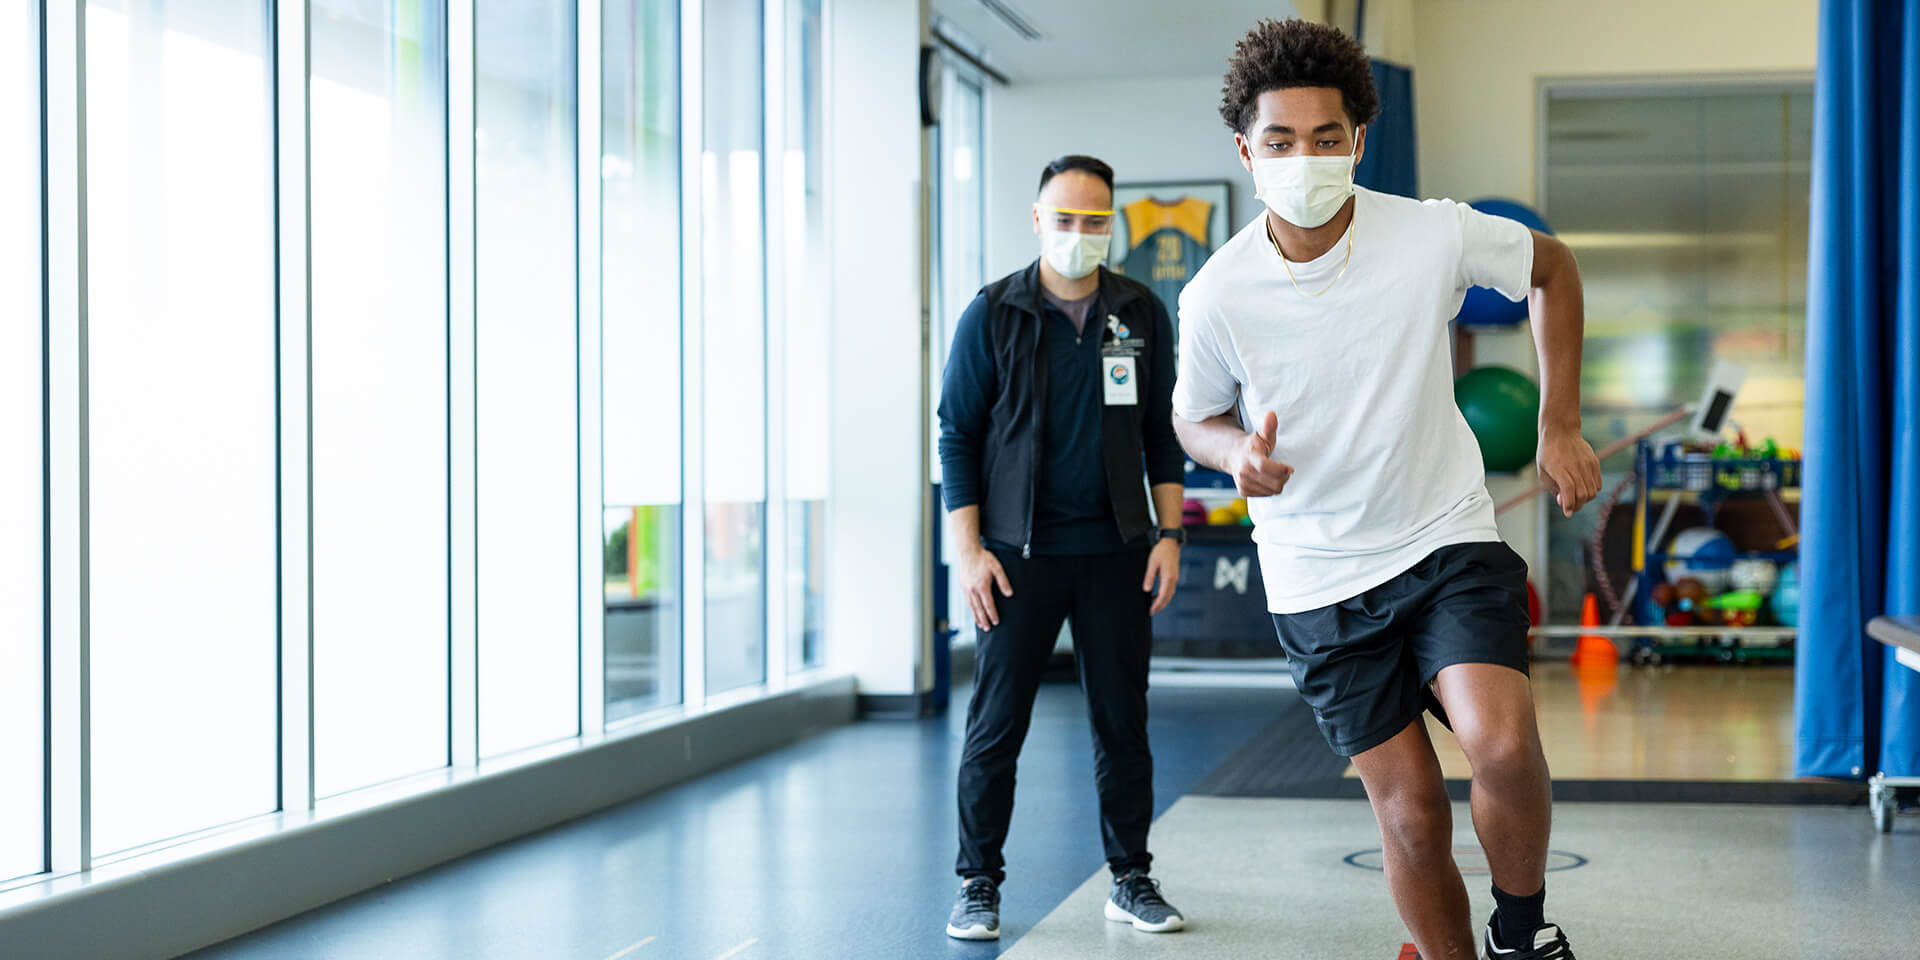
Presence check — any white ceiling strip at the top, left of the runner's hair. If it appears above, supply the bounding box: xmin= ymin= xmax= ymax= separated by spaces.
xmin=933 ymin=0 xmax=1296 ymax=83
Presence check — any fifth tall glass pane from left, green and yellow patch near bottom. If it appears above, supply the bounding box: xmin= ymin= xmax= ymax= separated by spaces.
xmin=601 ymin=0 xmax=682 ymax=722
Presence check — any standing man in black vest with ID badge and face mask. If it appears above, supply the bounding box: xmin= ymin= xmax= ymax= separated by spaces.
xmin=941 ymin=156 xmax=1187 ymax=941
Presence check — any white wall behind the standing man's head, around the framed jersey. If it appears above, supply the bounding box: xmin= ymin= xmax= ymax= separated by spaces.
xmin=962 ymin=76 xmax=1260 ymax=280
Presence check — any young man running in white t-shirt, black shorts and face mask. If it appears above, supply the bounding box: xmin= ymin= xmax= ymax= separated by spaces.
xmin=1173 ymin=21 xmax=1599 ymax=960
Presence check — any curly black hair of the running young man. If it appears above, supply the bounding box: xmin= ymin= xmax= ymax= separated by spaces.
xmin=1219 ymin=19 xmax=1380 ymax=132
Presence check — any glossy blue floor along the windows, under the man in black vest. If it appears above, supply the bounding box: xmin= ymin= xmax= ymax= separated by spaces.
xmin=183 ymin=684 xmax=1290 ymax=960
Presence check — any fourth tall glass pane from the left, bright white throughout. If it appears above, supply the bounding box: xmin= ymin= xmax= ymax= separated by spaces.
xmin=474 ymin=0 xmax=580 ymax=755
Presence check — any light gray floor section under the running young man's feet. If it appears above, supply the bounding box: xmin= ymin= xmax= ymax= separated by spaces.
xmin=1004 ymin=797 xmax=1920 ymax=960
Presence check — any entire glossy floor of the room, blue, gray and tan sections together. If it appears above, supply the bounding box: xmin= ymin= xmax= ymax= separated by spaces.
xmin=196 ymin=668 xmax=1881 ymax=960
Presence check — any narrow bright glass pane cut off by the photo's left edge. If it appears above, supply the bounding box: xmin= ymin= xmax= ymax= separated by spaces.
xmin=0 ymin=4 xmax=46 ymax=879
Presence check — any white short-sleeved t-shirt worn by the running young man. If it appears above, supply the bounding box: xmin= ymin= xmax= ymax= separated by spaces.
xmin=1173 ymin=188 xmax=1534 ymax=612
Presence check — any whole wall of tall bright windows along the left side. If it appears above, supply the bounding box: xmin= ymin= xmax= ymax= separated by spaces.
xmin=0 ymin=0 xmax=864 ymax=906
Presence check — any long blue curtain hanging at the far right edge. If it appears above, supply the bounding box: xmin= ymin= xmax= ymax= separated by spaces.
xmin=1793 ymin=0 xmax=1920 ymax=778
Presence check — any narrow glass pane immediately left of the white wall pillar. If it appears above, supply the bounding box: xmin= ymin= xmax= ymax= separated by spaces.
xmin=780 ymin=0 xmax=831 ymax=670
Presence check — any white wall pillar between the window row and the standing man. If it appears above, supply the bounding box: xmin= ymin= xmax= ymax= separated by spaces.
xmin=826 ymin=0 xmax=933 ymax=695
